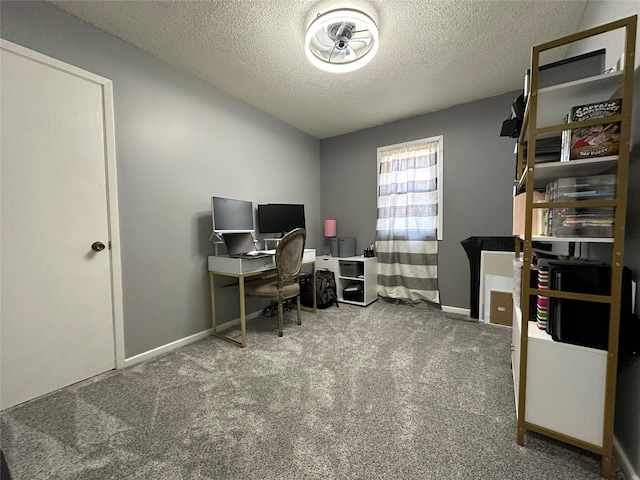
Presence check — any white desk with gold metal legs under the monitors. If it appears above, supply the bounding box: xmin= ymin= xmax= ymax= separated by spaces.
xmin=208 ymin=248 xmax=316 ymax=348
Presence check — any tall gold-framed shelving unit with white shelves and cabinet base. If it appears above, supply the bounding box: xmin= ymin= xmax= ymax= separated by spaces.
xmin=512 ymin=16 xmax=637 ymax=478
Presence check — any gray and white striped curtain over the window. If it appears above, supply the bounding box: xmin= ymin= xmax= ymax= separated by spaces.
xmin=376 ymin=137 xmax=442 ymax=304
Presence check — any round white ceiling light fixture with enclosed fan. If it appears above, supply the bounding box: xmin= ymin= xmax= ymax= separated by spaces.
xmin=305 ymin=9 xmax=378 ymax=72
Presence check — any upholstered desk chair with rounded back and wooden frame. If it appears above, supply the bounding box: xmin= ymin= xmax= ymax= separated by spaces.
xmin=244 ymin=228 xmax=307 ymax=337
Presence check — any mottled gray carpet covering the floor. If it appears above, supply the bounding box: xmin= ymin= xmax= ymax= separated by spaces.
xmin=1 ymin=301 xmax=624 ymax=480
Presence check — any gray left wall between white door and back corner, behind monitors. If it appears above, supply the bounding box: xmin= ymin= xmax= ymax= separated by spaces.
xmin=0 ymin=1 xmax=322 ymax=358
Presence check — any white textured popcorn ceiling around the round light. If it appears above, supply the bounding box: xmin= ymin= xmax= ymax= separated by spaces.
xmin=51 ymin=0 xmax=587 ymax=139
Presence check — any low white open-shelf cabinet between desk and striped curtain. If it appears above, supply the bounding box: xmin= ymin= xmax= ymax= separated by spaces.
xmin=316 ymin=255 xmax=378 ymax=307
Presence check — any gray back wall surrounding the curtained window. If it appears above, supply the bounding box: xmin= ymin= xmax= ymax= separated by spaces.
xmin=320 ymin=92 xmax=518 ymax=308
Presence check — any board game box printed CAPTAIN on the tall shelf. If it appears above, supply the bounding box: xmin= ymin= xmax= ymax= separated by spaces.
xmin=569 ymin=98 xmax=622 ymax=160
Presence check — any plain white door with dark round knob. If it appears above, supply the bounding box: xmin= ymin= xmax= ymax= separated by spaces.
xmin=0 ymin=42 xmax=122 ymax=409
